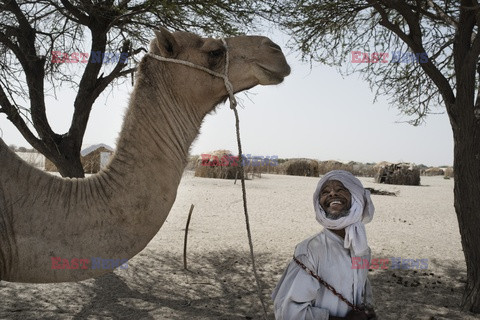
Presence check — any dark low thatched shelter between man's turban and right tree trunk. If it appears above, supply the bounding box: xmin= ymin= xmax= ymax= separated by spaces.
xmin=375 ymin=162 xmax=420 ymax=186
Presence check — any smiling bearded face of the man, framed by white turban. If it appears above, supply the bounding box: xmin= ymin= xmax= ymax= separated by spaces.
xmin=320 ymin=180 xmax=352 ymax=220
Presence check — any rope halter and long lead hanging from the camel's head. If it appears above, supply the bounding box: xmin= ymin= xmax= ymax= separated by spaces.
xmin=147 ymin=38 xmax=268 ymax=320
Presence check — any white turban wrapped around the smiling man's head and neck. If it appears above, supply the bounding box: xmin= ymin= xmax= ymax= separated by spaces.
xmin=313 ymin=170 xmax=375 ymax=256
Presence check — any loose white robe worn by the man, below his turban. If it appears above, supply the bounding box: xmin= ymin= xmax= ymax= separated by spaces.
xmin=272 ymin=229 xmax=373 ymax=320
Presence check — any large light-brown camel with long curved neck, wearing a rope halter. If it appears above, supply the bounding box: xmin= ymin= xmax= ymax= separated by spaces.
xmin=0 ymin=29 xmax=290 ymax=283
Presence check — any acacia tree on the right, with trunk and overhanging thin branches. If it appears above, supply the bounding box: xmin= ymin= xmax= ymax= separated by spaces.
xmin=270 ymin=0 xmax=480 ymax=313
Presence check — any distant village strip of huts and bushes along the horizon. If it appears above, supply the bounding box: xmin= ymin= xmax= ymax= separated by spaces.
xmin=10 ymin=143 xmax=454 ymax=185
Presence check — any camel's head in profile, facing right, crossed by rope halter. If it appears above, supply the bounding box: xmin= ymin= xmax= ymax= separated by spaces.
xmin=146 ymin=28 xmax=290 ymax=114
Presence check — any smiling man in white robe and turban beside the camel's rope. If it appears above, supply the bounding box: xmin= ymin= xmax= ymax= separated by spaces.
xmin=272 ymin=170 xmax=376 ymax=320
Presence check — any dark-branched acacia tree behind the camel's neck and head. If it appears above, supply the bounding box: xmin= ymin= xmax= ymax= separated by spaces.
xmin=0 ymin=0 xmax=255 ymax=177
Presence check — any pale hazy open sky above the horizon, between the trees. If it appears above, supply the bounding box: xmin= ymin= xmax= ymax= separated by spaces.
xmin=0 ymin=33 xmax=453 ymax=166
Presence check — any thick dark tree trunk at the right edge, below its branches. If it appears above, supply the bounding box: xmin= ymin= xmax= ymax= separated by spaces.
xmin=453 ymin=109 xmax=480 ymax=313
